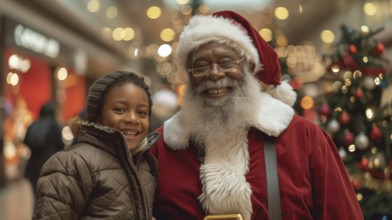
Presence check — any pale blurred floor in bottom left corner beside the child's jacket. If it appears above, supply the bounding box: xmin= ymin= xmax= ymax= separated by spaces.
xmin=0 ymin=179 xmax=34 ymax=220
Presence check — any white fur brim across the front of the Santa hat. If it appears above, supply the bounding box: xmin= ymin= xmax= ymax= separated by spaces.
xmin=177 ymin=15 xmax=261 ymax=72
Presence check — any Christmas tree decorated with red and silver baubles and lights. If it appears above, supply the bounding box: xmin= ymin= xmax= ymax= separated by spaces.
xmin=316 ymin=25 xmax=392 ymax=220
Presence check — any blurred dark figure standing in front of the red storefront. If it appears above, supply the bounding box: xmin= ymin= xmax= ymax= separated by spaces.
xmin=23 ymin=101 xmax=64 ymax=194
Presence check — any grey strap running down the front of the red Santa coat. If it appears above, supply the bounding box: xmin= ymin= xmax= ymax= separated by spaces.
xmin=264 ymin=140 xmax=281 ymax=220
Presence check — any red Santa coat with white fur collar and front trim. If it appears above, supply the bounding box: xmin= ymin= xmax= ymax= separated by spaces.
xmin=151 ymin=93 xmax=363 ymax=220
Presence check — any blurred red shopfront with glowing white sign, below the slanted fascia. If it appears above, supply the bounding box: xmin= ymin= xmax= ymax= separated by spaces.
xmin=0 ymin=17 xmax=86 ymax=181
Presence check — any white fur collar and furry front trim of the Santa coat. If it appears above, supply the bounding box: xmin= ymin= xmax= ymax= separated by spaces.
xmin=163 ymin=92 xmax=294 ymax=220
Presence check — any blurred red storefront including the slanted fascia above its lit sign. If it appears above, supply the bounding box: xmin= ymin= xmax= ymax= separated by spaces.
xmin=0 ymin=1 xmax=139 ymax=185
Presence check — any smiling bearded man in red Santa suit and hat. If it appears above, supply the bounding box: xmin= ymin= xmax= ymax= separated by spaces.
xmin=150 ymin=11 xmax=363 ymax=220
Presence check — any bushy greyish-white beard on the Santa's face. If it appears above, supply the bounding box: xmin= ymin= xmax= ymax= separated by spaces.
xmin=182 ymin=72 xmax=261 ymax=148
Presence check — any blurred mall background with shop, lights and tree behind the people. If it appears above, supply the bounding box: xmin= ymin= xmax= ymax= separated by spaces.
xmin=0 ymin=0 xmax=392 ymax=220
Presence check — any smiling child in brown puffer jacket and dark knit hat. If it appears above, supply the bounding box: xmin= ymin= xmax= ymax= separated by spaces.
xmin=33 ymin=71 xmax=159 ymax=220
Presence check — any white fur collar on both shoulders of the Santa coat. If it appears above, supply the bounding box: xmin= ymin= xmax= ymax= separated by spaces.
xmin=163 ymin=92 xmax=294 ymax=150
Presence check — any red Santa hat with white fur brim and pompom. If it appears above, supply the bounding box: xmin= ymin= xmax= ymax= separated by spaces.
xmin=177 ymin=11 xmax=297 ymax=106
